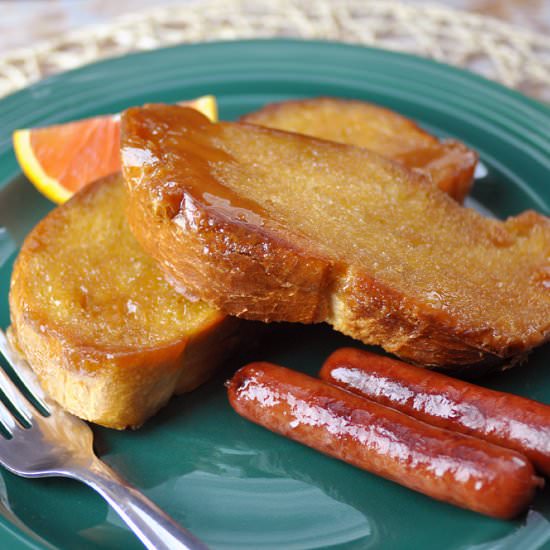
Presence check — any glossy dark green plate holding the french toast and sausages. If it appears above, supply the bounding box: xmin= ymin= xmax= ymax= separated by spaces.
xmin=0 ymin=40 xmax=550 ymax=550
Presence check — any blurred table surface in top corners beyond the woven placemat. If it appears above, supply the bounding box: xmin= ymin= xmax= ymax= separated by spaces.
xmin=0 ymin=0 xmax=550 ymax=54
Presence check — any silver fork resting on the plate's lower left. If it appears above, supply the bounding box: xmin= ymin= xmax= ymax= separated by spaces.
xmin=0 ymin=330 xmax=207 ymax=550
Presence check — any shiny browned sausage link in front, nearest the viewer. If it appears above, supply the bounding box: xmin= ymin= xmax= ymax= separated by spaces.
xmin=228 ymin=363 xmax=541 ymax=519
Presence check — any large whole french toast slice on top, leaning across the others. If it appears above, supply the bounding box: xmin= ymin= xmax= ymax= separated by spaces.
xmin=122 ymin=105 xmax=550 ymax=368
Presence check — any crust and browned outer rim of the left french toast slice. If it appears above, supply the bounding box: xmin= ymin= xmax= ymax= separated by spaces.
xmin=9 ymin=175 xmax=239 ymax=429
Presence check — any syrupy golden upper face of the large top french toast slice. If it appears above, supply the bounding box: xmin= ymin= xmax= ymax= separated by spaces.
xmin=123 ymin=105 xmax=550 ymax=341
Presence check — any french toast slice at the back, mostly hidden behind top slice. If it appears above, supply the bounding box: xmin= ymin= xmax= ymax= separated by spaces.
xmin=241 ymin=97 xmax=477 ymax=202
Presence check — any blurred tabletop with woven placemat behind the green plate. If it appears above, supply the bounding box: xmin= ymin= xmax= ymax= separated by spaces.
xmin=0 ymin=0 xmax=550 ymax=102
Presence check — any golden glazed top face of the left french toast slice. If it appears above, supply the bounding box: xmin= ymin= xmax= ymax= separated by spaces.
xmin=13 ymin=172 xmax=219 ymax=353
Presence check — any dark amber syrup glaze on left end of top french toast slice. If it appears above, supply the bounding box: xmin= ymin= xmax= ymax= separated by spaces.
xmin=121 ymin=105 xmax=265 ymax=229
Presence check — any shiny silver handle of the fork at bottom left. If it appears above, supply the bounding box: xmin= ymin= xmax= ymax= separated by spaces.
xmin=74 ymin=459 xmax=208 ymax=550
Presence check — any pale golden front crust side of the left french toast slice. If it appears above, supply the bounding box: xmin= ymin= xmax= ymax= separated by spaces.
xmin=10 ymin=312 xmax=236 ymax=430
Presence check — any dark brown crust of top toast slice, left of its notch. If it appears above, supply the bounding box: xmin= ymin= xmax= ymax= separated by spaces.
xmin=128 ymin=182 xmax=331 ymax=323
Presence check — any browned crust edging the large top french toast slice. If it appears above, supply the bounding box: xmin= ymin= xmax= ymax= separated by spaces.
xmin=122 ymin=106 xmax=550 ymax=371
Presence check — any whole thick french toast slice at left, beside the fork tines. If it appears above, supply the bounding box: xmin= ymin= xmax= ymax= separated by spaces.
xmin=10 ymin=174 xmax=237 ymax=429
